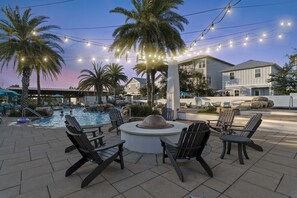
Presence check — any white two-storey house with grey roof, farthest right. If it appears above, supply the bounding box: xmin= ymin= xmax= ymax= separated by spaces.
xmin=221 ymin=60 xmax=279 ymax=96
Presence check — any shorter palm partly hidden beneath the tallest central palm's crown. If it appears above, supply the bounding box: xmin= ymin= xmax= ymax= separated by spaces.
xmin=133 ymin=60 xmax=168 ymax=105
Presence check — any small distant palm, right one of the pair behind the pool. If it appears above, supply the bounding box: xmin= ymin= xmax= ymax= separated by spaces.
xmin=106 ymin=63 xmax=128 ymax=102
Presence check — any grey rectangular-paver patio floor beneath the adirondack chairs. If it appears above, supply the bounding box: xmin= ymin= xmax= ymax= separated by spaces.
xmin=0 ymin=117 xmax=297 ymax=198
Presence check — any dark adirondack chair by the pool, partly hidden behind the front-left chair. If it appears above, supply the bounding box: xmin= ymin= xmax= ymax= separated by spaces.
xmin=65 ymin=115 xmax=104 ymax=153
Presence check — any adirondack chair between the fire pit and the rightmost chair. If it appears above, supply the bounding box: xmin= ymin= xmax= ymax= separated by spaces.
xmin=207 ymin=110 xmax=235 ymax=132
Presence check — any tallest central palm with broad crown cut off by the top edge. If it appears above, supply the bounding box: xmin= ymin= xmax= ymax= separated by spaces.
xmin=110 ymin=0 xmax=188 ymax=104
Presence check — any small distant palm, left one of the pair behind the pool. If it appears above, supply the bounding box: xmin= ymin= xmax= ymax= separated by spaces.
xmin=78 ymin=62 xmax=111 ymax=104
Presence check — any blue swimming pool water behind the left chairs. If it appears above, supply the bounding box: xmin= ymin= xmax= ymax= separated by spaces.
xmin=32 ymin=108 xmax=109 ymax=128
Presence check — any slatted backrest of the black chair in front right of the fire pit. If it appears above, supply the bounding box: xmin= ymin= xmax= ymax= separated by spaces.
xmin=175 ymin=122 xmax=210 ymax=159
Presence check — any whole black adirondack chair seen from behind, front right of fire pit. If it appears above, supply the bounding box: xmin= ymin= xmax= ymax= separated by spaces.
xmin=160 ymin=121 xmax=213 ymax=182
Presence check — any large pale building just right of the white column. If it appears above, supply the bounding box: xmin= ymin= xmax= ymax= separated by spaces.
xmin=178 ymin=55 xmax=234 ymax=90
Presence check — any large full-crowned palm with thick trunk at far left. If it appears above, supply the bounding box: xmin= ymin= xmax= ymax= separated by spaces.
xmin=0 ymin=6 xmax=63 ymax=108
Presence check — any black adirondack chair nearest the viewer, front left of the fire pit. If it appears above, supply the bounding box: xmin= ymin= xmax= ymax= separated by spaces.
xmin=65 ymin=125 xmax=125 ymax=188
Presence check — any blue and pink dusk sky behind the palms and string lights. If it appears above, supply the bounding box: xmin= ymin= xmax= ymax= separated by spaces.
xmin=0 ymin=0 xmax=297 ymax=88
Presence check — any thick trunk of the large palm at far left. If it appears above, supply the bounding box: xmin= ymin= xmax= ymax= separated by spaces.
xmin=21 ymin=67 xmax=31 ymax=109
